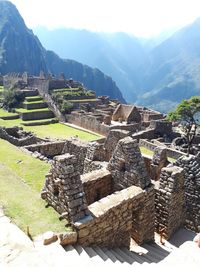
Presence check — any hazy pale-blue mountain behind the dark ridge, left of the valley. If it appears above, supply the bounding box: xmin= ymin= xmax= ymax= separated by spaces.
xmin=33 ymin=27 xmax=148 ymax=102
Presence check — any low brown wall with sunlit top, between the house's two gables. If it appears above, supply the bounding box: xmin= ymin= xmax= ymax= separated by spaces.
xmin=81 ymin=169 xmax=112 ymax=205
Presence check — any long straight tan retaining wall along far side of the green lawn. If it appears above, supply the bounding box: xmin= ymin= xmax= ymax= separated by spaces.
xmin=66 ymin=112 xmax=110 ymax=136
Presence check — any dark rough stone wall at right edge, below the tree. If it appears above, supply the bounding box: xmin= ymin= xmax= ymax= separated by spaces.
xmin=175 ymin=155 xmax=200 ymax=232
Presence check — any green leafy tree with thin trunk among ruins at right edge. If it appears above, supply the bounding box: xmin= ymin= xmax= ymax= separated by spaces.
xmin=168 ymin=96 xmax=200 ymax=154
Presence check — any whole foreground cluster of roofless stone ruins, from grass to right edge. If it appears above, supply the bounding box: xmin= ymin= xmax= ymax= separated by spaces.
xmin=41 ymin=130 xmax=200 ymax=247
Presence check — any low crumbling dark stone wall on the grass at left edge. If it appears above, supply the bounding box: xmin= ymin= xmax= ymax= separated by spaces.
xmin=0 ymin=127 xmax=39 ymax=146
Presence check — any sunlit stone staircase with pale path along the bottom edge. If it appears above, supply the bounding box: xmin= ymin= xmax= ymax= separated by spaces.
xmin=0 ymin=207 xmax=200 ymax=267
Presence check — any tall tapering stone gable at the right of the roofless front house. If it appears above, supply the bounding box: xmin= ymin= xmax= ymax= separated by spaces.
xmin=108 ymin=137 xmax=151 ymax=191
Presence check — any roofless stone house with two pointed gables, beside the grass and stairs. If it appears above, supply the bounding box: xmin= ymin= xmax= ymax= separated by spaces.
xmin=42 ymin=137 xmax=154 ymax=246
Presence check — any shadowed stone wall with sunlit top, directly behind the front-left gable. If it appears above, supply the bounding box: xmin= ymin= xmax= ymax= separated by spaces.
xmin=62 ymin=138 xmax=89 ymax=174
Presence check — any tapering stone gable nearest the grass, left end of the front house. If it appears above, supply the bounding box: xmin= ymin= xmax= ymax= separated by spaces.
xmin=41 ymin=154 xmax=89 ymax=222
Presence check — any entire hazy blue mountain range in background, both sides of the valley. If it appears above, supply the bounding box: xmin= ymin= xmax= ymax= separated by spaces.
xmin=34 ymin=20 xmax=200 ymax=112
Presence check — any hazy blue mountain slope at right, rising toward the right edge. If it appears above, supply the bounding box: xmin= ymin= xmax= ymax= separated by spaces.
xmin=139 ymin=19 xmax=200 ymax=111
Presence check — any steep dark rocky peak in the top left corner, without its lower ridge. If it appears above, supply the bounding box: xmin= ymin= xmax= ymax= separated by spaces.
xmin=0 ymin=1 xmax=47 ymax=74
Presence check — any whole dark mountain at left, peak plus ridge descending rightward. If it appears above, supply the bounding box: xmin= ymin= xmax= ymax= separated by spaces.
xmin=0 ymin=1 xmax=125 ymax=102
